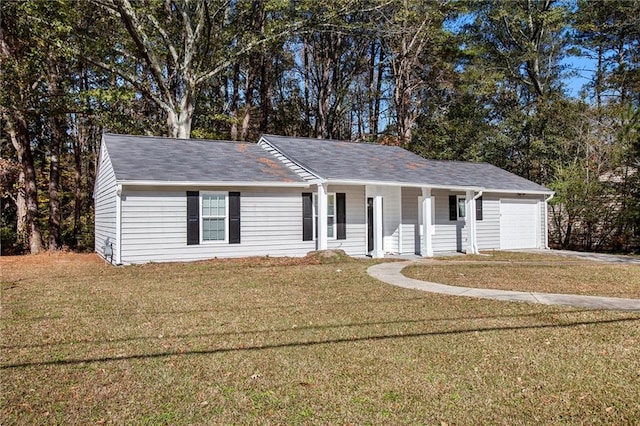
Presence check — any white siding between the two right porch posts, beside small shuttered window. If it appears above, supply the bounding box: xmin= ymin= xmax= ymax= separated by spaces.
xmin=432 ymin=190 xmax=467 ymax=253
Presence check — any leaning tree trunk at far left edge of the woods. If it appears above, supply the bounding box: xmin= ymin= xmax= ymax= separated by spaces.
xmin=3 ymin=110 xmax=42 ymax=254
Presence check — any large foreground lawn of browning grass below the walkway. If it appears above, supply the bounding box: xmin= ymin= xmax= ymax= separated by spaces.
xmin=0 ymin=255 xmax=640 ymax=425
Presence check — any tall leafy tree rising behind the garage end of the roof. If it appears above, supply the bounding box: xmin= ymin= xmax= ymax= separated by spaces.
xmin=466 ymin=0 xmax=569 ymax=183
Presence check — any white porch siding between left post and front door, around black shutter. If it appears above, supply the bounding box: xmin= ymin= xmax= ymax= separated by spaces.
xmin=327 ymin=185 xmax=367 ymax=256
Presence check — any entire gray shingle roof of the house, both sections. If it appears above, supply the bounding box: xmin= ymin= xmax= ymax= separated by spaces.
xmin=103 ymin=134 xmax=551 ymax=193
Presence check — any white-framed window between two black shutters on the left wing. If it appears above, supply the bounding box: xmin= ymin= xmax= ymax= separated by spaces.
xmin=200 ymin=192 xmax=229 ymax=242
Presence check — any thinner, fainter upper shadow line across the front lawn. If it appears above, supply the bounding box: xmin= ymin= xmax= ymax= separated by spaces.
xmin=0 ymin=305 xmax=596 ymax=349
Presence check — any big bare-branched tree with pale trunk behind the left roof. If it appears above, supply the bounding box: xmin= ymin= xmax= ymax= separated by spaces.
xmin=90 ymin=0 xmax=300 ymax=138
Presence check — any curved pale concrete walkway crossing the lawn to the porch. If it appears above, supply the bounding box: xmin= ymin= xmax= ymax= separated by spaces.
xmin=367 ymin=261 xmax=640 ymax=311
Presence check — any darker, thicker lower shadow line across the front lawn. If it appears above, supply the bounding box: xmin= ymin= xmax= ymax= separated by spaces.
xmin=0 ymin=317 xmax=640 ymax=370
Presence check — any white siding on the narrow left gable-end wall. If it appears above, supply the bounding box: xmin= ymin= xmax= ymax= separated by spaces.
xmin=94 ymin=144 xmax=118 ymax=254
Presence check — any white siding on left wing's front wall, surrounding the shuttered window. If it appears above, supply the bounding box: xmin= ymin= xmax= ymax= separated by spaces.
xmin=122 ymin=187 xmax=315 ymax=263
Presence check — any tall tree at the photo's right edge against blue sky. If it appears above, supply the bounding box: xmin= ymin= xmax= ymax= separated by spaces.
xmin=574 ymin=0 xmax=640 ymax=249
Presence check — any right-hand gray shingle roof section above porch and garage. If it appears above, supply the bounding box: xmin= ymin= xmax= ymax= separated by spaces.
xmin=263 ymin=135 xmax=551 ymax=193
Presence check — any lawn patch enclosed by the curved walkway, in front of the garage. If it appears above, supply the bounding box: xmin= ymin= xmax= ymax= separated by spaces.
xmin=402 ymin=252 xmax=640 ymax=299
